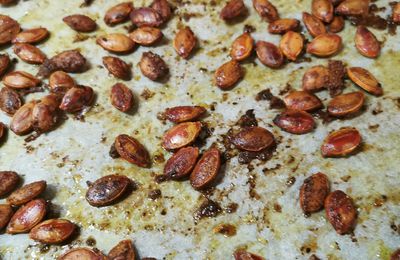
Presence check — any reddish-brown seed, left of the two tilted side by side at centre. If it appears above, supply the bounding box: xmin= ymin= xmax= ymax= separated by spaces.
xmin=164 ymin=147 xmax=199 ymax=179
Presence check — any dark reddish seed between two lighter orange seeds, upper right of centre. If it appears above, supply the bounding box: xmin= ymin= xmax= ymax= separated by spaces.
xmin=256 ymin=41 xmax=284 ymax=69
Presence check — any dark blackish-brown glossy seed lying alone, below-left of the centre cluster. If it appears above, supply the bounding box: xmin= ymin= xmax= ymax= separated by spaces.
xmin=86 ymin=174 xmax=131 ymax=207
